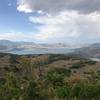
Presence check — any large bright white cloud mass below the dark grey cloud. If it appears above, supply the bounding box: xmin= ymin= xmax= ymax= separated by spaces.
xmin=29 ymin=11 xmax=100 ymax=41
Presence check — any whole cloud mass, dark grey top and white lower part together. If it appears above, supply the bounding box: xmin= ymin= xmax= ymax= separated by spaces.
xmin=17 ymin=0 xmax=100 ymax=42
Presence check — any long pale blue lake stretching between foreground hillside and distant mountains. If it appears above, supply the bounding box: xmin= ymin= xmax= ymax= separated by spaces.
xmin=8 ymin=48 xmax=74 ymax=55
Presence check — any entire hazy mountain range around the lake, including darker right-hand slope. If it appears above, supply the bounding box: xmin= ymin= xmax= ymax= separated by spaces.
xmin=0 ymin=40 xmax=100 ymax=58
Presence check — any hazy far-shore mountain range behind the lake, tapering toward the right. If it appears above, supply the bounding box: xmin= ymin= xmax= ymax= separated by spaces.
xmin=0 ymin=40 xmax=86 ymax=52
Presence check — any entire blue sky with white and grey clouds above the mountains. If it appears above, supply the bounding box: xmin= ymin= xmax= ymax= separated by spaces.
xmin=0 ymin=0 xmax=100 ymax=43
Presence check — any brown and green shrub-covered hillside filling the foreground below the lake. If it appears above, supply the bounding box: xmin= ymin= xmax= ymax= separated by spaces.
xmin=0 ymin=53 xmax=100 ymax=100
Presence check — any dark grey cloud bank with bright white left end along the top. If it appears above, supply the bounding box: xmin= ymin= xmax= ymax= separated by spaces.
xmin=17 ymin=0 xmax=100 ymax=13
